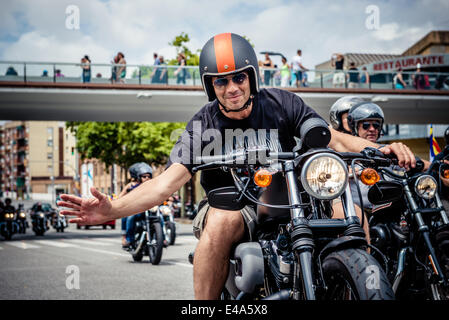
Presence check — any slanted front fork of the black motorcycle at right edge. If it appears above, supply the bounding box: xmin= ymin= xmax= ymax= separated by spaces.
xmin=404 ymin=184 xmax=447 ymax=286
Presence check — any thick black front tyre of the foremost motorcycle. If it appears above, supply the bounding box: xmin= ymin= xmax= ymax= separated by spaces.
xmin=323 ymin=249 xmax=395 ymax=300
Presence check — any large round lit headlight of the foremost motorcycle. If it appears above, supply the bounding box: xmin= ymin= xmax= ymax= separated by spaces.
xmin=301 ymin=153 xmax=348 ymax=200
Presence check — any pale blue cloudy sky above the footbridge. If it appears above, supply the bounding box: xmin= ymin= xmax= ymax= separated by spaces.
xmin=0 ymin=0 xmax=449 ymax=68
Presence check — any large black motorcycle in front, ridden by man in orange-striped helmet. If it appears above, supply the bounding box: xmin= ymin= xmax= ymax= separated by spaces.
xmin=193 ymin=119 xmax=394 ymax=300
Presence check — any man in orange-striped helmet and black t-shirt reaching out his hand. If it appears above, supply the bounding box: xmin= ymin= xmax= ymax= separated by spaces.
xmin=61 ymin=33 xmax=415 ymax=299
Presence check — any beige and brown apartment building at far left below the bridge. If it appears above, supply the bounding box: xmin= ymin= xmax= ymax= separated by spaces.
xmin=0 ymin=121 xmax=78 ymax=201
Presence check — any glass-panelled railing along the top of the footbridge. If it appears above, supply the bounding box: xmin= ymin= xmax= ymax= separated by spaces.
xmin=0 ymin=61 xmax=449 ymax=90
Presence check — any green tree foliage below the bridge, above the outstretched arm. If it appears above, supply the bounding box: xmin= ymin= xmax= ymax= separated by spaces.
xmin=66 ymin=121 xmax=186 ymax=169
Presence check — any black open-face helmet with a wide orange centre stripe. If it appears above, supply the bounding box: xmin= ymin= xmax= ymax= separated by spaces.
xmin=200 ymin=33 xmax=259 ymax=101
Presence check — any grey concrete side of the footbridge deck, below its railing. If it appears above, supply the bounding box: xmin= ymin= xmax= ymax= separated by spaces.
xmin=0 ymin=84 xmax=449 ymax=124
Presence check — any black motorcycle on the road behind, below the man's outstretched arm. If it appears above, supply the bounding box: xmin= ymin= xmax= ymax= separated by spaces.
xmin=129 ymin=208 xmax=164 ymax=265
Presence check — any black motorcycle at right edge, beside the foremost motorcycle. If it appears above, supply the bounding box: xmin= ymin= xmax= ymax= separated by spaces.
xmin=356 ymin=149 xmax=449 ymax=300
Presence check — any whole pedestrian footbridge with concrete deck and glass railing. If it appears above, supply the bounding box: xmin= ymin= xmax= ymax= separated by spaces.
xmin=0 ymin=62 xmax=449 ymax=124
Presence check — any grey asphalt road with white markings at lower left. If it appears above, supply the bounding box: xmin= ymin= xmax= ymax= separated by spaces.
xmin=0 ymin=215 xmax=197 ymax=300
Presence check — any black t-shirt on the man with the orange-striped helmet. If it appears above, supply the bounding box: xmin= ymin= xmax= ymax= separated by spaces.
xmin=168 ymin=88 xmax=321 ymax=192
